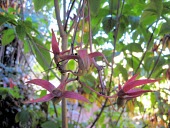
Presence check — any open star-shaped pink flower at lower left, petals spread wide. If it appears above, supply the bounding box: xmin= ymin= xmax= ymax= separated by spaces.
xmin=24 ymin=79 xmax=89 ymax=103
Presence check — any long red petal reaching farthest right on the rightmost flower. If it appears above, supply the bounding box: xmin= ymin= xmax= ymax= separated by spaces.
xmin=122 ymin=79 xmax=157 ymax=92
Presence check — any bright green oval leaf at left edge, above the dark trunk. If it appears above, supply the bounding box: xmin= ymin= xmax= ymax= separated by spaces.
xmin=2 ymin=29 xmax=15 ymax=46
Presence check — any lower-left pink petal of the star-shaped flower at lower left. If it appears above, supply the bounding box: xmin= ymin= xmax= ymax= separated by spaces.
xmin=24 ymin=93 xmax=54 ymax=104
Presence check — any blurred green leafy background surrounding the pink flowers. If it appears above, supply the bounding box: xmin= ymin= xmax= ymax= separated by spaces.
xmin=0 ymin=0 xmax=170 ymax=128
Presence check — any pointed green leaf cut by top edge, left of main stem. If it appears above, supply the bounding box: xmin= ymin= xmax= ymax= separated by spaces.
xmin=33 ymin=0 xmax=50 ymax=12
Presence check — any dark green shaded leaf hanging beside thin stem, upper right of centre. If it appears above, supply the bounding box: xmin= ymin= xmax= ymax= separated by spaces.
xmin=102 ymin=16 xmax=116 ymax=33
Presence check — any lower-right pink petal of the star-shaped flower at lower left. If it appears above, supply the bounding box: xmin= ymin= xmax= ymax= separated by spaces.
xmin=63 ymin=91 xmax=89 ymax=103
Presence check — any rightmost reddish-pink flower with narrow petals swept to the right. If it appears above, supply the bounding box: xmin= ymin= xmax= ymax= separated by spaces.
xmin=117 ymin=74 xmax=157 ymax=108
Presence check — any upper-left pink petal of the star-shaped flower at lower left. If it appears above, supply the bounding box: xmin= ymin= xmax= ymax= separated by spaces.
xmin=26 ymin=79 xmax=55 ymax=92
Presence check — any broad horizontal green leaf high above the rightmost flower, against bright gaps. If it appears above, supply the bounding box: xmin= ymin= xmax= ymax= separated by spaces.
xmin=125 ymin=43 xmax=143 ymax=52
